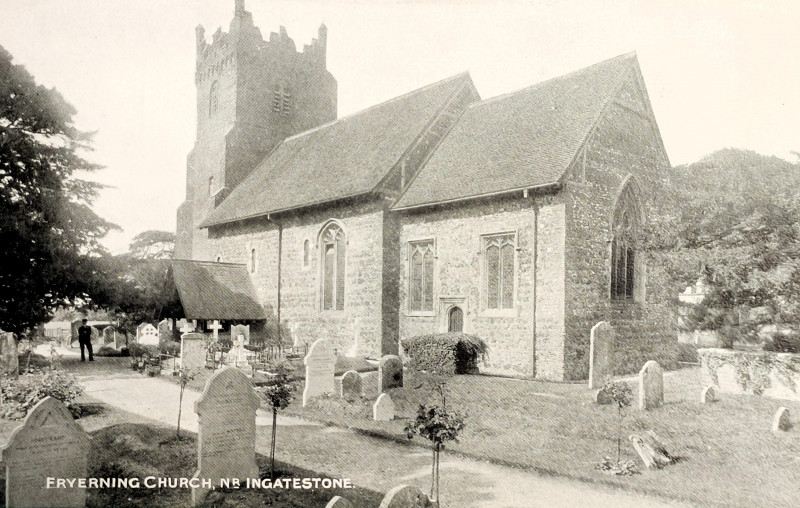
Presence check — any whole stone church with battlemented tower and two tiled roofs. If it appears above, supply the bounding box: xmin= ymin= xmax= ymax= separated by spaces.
xmin=175 ymin=0 xmax=674 ymax=380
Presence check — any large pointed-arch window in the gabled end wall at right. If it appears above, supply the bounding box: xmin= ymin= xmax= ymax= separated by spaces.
xmin=611 ymin=182 xmax=643 ymax=301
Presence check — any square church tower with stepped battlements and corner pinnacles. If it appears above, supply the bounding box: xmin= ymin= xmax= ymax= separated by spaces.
xmin=175 ymin=0 xmax=336 ymax=261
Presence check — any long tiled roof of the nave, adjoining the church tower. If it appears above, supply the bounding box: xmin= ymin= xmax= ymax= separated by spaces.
xmin=200 ymin=73 xmax=473 ymax=227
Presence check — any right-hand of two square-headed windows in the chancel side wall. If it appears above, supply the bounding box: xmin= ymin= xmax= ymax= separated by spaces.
xmin=483 ymin=233 xmax=516 ymax=309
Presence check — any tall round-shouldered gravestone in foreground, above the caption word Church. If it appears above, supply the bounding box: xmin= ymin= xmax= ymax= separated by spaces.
xmin=192 ymin=367 xmax=261 ymax=505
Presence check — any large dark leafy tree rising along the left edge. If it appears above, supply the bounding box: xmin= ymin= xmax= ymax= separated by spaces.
xmin=0 ymin=47 xmax=116 ymax=332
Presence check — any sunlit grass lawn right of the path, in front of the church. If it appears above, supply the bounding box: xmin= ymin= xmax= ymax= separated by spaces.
xmin=286 ymin=367 xmax=800 ymax=506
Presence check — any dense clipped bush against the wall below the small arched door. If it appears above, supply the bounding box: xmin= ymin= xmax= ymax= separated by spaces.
xmin=403 ymin=333 xmax=488 ymax=374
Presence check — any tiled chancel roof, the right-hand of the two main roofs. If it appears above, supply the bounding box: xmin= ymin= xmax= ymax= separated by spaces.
xmin=394 ymin=53 xmax=638 ymax=209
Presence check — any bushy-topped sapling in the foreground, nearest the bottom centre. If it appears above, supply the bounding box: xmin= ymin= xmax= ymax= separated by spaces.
xmin=405 ymin=402 xmax=464 ymax=506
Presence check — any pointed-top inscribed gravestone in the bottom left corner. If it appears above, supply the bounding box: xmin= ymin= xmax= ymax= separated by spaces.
xmin=0 ymin=397 xmax=91 ymax=508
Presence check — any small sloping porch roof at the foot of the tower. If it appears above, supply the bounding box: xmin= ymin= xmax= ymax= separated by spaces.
xmin=172 ymin=259 xmax=267 ymax=321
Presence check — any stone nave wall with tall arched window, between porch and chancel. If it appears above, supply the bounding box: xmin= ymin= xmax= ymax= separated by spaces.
xmin=210 ymin=201 xmax=390 ymax=357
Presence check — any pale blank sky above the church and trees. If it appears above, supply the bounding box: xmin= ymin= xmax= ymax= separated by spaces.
xmin=0 ymin=0 xmax=800 ymax=253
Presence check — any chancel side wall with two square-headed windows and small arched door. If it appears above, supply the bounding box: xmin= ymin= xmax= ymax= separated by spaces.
xmin=399 ymin=193 xmax=564 ymax=378
